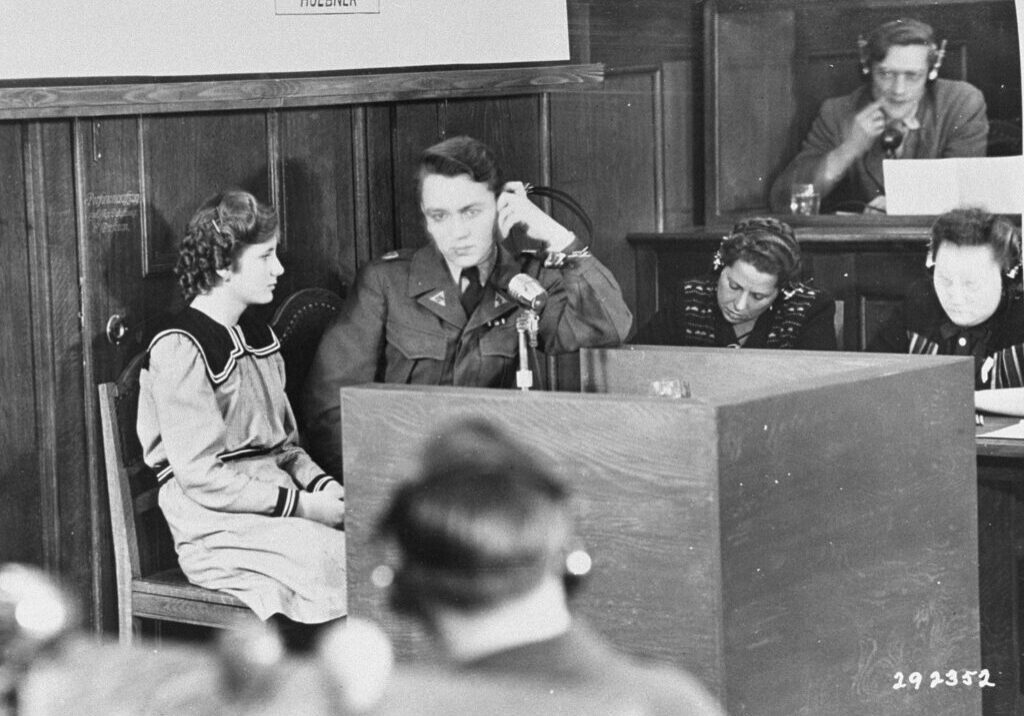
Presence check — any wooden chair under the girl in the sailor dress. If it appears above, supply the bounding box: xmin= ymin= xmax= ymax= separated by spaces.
xmin=99 ymin=353 xmax=256 ymax=643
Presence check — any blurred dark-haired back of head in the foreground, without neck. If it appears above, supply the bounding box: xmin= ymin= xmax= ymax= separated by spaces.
xmin=379 ymin=419 xmax=589 ymax=626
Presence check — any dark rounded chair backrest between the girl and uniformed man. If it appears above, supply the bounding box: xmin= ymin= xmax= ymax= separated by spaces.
xmin=270 ymin=288 xmax=343 ymax=420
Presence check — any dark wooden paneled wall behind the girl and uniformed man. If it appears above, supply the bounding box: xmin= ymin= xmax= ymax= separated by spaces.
xmin=0 ymin=51 xmax=696 ymax=625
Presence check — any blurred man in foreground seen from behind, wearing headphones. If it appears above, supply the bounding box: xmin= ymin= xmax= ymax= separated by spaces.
xmin=379 ymin=419 xmax=722 ymax=716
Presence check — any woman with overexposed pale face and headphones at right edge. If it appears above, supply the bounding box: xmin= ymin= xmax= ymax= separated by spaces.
xmin=868 ymin=208 xmax=1024 ymax=408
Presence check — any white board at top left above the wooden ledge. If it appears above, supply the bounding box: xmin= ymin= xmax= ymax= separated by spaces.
xmin=0 ymin=0 xmax=569 ymax=83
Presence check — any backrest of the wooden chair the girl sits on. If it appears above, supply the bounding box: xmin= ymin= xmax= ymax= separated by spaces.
xmin=99 ymin=352 xmax=177 ymax=603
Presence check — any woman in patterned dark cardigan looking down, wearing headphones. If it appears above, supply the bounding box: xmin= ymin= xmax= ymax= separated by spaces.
xmin=632 ymin=217 xmax=836 ymax=350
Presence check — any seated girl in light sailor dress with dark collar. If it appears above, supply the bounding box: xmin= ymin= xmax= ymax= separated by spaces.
xmin=137 ymin=191 xmax=346 ymax=647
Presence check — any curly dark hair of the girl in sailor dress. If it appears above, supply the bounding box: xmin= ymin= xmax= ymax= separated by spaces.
xmin=174 ymin=189 xmax=279 ymax=301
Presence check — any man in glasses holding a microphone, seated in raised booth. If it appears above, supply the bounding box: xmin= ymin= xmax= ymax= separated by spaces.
xmin=771 ymin=19 xmax=988 ymax=212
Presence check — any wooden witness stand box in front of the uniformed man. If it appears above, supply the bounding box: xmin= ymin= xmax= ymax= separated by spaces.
xmin=341 ymin=347 xmax=981 ymax=716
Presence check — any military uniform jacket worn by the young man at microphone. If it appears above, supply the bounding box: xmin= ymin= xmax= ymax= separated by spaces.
xmin=302 ymin=244 xmax=633 ymax=474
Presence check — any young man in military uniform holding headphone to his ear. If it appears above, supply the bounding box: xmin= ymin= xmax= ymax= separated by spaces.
xmin=301 ymin=136 xmax=633 ymax=474
